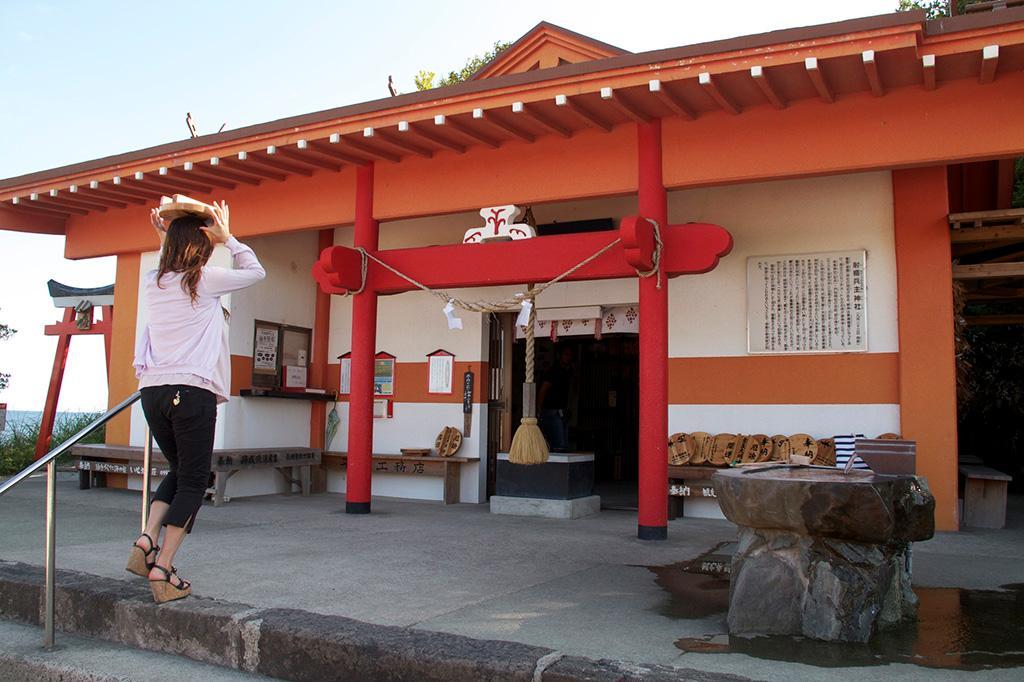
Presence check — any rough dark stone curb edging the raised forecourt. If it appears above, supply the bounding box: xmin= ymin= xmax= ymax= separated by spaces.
xmin=0 ymin=560 xmax=745 ymax=682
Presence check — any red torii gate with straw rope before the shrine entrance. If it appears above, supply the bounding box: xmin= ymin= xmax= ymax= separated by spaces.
xmin=313 ymin=120 xmax=732 ymax=540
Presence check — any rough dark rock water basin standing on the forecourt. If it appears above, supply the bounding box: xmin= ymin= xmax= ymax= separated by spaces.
xmin=712 ymin=467 xmax=935 ymax=642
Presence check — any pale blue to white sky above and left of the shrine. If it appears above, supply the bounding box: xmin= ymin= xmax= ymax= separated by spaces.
xmin=0 ymin=0 xmax=898 ymax=410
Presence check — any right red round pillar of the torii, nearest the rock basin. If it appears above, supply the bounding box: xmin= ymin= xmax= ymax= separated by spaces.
xmin=637 ymin=119 xmax=669 ymax=540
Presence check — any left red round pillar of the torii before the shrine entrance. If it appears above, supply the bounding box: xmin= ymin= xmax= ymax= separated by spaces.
xmin=345 ymin=164 xmax=380 ymax=514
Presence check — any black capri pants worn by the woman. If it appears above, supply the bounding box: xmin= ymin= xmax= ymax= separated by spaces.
xmin=141 ymin=385 xmax=217 ymax=532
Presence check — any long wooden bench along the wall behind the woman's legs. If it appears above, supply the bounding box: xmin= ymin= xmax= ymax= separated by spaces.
xmin=72 ymin=444 xmax=321 ymax=507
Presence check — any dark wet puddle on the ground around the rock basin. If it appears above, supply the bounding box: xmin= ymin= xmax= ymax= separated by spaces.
xmin=649 ymin=545 xmax=1024 ymax=671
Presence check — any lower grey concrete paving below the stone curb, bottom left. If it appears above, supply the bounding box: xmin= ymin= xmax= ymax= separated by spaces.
xmin=0 ymin=621 xmax=270 ymax=682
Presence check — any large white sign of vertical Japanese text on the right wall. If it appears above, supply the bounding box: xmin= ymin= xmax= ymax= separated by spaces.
xmin=746 ymin=251 xmax=867 ymax=353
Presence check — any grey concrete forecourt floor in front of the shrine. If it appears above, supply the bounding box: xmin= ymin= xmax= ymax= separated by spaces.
xmin=0 ymin=474 xmax=1024 ymax=682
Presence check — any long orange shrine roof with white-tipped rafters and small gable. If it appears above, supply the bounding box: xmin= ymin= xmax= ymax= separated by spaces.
xmin=0 ymin=8 xmax=1024 ymax=233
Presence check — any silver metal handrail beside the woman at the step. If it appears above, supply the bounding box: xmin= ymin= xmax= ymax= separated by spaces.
xmin=0 ymin=391 xmax=153 ymax=649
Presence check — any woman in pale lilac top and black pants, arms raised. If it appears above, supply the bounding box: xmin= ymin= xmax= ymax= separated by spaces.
xmin=127 ymin=202 xmax=266 ymax=603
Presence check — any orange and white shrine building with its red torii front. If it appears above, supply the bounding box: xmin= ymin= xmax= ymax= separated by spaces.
xmin=0 ymin=8 xmax=1024 ymax=539
